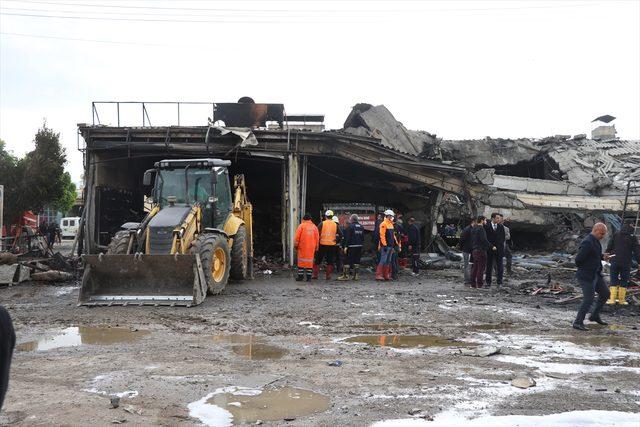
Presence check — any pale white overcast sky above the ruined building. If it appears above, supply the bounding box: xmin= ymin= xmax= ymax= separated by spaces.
xmin=0 ymin=0 xmax=640 ymax=180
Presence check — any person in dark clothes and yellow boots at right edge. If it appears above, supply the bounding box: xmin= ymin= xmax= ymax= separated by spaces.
xmin=605 ymin=221 xmax=640 ymax=305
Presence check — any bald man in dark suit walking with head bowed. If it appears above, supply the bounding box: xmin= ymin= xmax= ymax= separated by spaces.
xmin=573 ymin=222 xmax=609 ymax=331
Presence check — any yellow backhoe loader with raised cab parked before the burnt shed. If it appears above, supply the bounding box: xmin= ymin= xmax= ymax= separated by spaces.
xmin=79 ymin=159 xmax=253 ymax=306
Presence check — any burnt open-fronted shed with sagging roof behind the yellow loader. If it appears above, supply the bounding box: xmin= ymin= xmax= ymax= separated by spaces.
xmin=78 ymin=99 xmax=474 ymax=262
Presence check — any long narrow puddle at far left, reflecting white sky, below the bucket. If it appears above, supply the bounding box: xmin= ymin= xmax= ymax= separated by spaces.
xmin=17 ymin=326 xmax=150 ymax=351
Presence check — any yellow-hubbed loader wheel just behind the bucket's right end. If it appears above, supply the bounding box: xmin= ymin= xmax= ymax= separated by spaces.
xmin=192 ymin=234 xmax=231 ymax=295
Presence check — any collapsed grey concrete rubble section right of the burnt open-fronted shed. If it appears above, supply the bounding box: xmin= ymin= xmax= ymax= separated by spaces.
xmin=345 ymin=104 xmax=640 ymax=252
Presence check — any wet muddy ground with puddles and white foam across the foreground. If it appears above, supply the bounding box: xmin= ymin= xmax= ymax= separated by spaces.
xmin=0 ymin=254 xmax=640 ymax=426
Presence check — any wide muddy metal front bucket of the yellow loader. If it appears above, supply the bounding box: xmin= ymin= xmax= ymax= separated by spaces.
xmin=79 ymin=254 xmax=207 ymax=307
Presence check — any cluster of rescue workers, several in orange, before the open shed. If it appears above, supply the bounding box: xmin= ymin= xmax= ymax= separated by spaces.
xmin=293 ymin=209 xmax=420 ymax=281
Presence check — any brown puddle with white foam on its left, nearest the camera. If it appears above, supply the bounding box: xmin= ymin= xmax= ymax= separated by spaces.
xmin=189 ymin=387 xmax=329 ymax=426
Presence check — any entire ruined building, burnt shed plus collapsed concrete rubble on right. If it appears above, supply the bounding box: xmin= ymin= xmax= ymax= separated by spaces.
xmin=78 ymin=98 xmax=640 ymax=262
